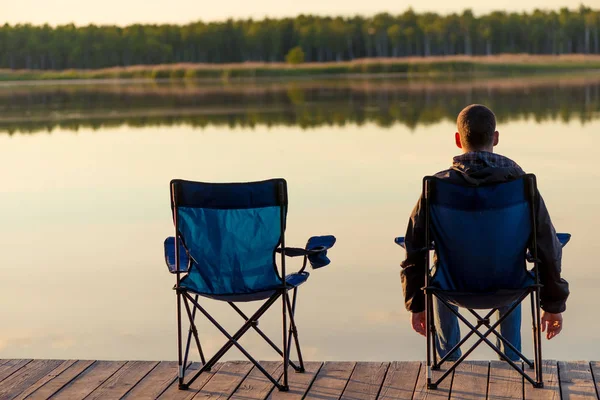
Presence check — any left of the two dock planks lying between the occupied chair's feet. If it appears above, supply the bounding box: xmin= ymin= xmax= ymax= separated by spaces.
xmin=450 ymin=361 xmax=490 ymax=400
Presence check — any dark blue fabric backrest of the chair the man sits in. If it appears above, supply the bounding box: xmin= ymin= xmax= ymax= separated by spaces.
xmin=424 ymin=175 xmax=535 ymax=293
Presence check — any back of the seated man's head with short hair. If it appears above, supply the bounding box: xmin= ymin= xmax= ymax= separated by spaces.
xmin=456 ymin=104 xmax=496 ymax=150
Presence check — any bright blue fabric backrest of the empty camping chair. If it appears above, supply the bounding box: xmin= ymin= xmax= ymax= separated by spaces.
xmin=171 ymin=179 xmax=287 ymax=295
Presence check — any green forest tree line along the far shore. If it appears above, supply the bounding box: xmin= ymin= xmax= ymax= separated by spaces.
xmin=0 ymin=6 xmax=600 ymax=70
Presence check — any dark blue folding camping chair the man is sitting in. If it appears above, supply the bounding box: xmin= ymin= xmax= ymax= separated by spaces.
xmin=395 ymin=174 xmax=570 ymax=389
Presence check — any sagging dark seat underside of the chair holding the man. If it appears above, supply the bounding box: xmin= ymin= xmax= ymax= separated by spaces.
xmin=427 ymin=285 xmax=536 ymax=310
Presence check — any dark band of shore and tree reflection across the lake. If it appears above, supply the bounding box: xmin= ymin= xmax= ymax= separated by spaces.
xmin=0 ymin=75 xmax=600 ymax=134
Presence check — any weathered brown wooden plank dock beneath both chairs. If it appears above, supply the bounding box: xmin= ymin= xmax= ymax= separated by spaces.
xmin=0 ymin=360 xmax=600 ymax=400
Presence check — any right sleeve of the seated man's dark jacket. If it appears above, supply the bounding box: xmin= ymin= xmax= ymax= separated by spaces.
xmin=536 ymin=193 xmax=569 ymax=313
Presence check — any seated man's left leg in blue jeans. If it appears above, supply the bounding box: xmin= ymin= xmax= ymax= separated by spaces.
xmin=433 ymin=296 xmax=462 ymax=361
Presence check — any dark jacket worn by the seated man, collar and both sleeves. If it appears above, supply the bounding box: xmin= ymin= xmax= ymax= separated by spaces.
xmin=400 ymin=152 xmax=569 ymax=313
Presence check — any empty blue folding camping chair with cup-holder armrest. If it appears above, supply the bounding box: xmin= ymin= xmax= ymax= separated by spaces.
xmin=165 ymin=179 xmax=335 ymax=391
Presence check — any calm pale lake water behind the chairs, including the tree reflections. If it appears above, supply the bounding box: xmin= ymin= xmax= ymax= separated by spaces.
xmin=0 ymin=77 xmax=600 ymax=360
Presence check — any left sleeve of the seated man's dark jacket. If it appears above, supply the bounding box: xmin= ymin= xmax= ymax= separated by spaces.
xmin=400 ymin=199 xmax=427 ymax=313
